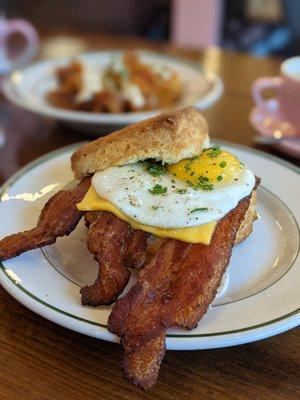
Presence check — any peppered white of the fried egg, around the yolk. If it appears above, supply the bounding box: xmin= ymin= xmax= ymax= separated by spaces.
xmin=92 ymin=163 xmax=255 ymax=229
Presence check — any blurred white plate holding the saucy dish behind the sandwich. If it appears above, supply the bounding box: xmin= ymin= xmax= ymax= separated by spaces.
xmin=3 ymin=51 xmax=223 ymax=133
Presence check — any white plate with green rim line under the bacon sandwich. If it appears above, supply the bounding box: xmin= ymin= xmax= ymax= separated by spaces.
xmin=0 ymin=142 xmax=300 ymax=350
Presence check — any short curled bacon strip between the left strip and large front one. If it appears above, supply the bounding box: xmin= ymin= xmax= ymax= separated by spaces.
xmin=80 ymin=211 xmax=148 ymax=307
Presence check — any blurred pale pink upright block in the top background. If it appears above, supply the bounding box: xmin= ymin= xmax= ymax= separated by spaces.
xmin=171 ymin=0 xmax=223 ymax=47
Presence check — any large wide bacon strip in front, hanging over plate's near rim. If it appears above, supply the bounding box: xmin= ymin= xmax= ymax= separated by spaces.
xmin=108 ymin=192 xmax=250 ymax=389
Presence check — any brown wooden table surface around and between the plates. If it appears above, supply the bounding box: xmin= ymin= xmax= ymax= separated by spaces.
xmin=0 ymin=35 xmax=300 ymax=400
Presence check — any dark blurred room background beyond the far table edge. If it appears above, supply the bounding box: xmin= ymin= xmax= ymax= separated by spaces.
xmin=0 ymin=0 xmax=300 ymax=57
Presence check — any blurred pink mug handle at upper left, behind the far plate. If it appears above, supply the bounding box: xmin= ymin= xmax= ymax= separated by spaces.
xmin=0 ymin=15 xmax=39 ymax=75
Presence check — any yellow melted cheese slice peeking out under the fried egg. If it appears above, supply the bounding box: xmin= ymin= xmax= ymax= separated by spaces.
xmin=77 ymin=186 xmax=217 ymax=244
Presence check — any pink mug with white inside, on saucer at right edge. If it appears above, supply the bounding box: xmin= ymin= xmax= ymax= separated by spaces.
xmin=252 ymin=56 xmax=300 ymax=128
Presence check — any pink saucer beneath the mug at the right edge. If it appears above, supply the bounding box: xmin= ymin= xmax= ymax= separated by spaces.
xmin=250 ymin=98 xmax=300 ymax=158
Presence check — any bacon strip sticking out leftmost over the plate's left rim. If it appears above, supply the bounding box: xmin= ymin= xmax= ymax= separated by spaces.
xmin=0 ymin=178 xmax=91 ymax=261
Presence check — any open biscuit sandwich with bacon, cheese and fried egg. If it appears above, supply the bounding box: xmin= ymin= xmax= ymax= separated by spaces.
xmin=0 ymin=108 xmax=259 ymax=388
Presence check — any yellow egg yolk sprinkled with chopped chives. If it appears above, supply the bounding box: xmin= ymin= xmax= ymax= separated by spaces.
xmin=167 ymin=147 xmax=244 ymax=190
